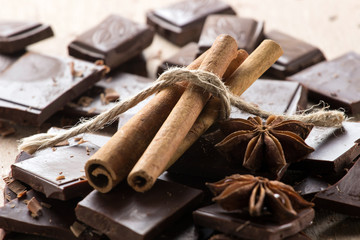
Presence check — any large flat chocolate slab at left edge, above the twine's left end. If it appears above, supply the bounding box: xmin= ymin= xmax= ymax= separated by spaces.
xmin=0 ymin=53 xmax=105 ymax=125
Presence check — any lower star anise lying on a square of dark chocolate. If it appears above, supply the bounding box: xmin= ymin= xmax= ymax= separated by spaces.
xmin=207 ymin=174 xmax=314 ymax=221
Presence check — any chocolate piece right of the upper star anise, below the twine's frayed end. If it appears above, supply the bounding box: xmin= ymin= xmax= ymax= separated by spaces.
xmin=298 ymin=122 xmax=360 ymax=177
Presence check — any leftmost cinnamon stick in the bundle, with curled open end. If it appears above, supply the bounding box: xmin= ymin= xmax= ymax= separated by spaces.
xmin=85 ymin=49 xmax=207 ymax=193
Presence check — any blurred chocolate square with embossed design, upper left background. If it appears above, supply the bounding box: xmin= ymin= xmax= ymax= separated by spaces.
xmin=68 ymin=15 xmax=154 ymax=68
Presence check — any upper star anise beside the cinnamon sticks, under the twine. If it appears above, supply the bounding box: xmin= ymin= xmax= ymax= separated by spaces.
xmin=215 ymin=116 xmax=314 ymax=173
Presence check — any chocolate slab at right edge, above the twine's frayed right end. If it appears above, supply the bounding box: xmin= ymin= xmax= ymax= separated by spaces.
xmin=287 ymin=52 xmax=360 ymax=114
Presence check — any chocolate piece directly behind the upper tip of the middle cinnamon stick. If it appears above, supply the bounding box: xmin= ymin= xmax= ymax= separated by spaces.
xmin=199 ymin=15 xmax=264 ymax=53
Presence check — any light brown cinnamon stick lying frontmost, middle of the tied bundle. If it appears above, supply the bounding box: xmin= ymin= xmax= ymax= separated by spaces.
xmin=128 ymin=35 xmax=237 ymax=192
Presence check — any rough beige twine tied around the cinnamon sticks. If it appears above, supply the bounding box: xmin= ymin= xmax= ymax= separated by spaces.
xmin=19 ymin=68 xmax=345 ymax=153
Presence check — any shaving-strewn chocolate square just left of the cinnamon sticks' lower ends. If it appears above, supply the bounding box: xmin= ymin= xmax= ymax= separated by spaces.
xmin=11 ymin=134 xmax=109 ymax=200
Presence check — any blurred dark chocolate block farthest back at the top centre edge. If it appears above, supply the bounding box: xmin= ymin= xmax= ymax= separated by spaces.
xmin=146 ymin=0 xmax=235 ymax=46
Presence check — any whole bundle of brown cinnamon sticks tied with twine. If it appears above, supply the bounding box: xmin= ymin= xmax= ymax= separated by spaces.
xmin=85 ymin=35 xmax=282 ymax=193
